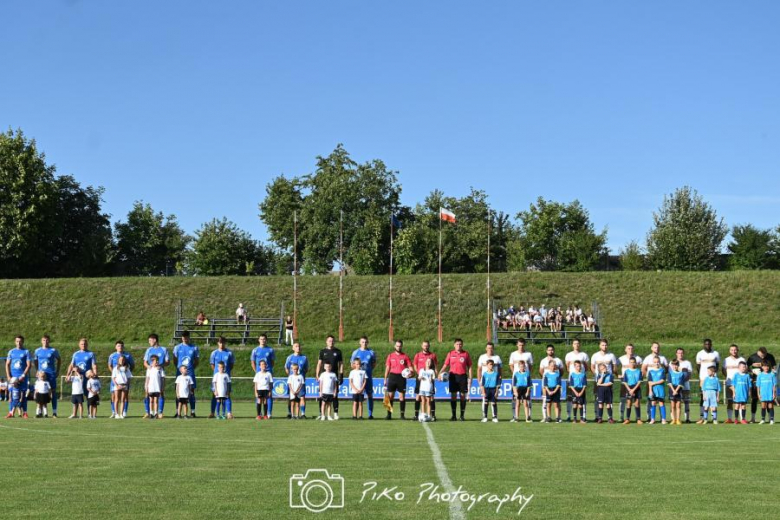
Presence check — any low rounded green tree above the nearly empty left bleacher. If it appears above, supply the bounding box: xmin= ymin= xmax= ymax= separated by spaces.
xmin=188 ymin=218 xmax=271 ymax=276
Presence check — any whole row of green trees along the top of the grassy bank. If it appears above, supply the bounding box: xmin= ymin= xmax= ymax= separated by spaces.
xmin=0 ymin=130 xmax=780 ymax=278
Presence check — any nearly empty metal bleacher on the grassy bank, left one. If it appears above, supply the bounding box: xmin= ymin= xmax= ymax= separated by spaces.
xmin=172 ymin=300 xmax=284 ymax=345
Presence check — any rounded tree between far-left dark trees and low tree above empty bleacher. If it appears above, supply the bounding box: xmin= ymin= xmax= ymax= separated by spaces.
xmin=115 ymin=201 xmax=191 ymax=276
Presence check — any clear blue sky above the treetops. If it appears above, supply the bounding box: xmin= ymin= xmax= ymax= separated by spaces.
xmin=0 ymin=0 xmax=780 ymax=252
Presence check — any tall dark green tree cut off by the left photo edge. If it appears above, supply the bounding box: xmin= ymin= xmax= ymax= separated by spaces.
xmin=0 ymin=130 xmax=57 ymax=277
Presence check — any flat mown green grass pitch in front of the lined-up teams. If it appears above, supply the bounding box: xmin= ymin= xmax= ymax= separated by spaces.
xmin=0 ymin=401 xmax=780 ymax=519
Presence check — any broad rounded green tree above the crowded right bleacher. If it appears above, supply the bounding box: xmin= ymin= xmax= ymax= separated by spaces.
xmin=517 ymin=197 xmax=607 ymax=271
